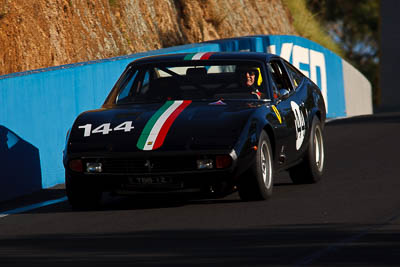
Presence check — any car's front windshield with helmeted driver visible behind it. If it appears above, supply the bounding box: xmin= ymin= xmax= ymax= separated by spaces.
xmin=107 ymin=62 xmax=266 ymax=105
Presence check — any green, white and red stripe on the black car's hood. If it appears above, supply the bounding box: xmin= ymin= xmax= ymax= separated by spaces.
xmin=137 ymin=100 xmax=192 ymax=150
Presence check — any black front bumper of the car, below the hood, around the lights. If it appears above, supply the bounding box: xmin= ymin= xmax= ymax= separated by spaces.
xmin=64 ymin=150 xmax=256 ymax=193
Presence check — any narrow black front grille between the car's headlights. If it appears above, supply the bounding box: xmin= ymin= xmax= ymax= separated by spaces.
xmin=86 ymin=157 xmax=197 ymax=174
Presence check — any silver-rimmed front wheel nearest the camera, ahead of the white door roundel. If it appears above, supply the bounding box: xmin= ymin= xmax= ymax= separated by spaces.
xmin=238 ymin=131 xmax=274 ymax=201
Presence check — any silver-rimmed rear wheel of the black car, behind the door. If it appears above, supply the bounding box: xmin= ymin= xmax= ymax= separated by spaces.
xmin=289 ymin=116 xmax=325 ymax=184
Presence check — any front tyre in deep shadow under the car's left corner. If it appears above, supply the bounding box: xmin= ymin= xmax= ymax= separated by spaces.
xmin=65 ymin=174 xmax=102 ymax=210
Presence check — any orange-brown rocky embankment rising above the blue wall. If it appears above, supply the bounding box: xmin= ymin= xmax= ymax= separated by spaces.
xmin=0 ymin=0 xmax=295 ymax=75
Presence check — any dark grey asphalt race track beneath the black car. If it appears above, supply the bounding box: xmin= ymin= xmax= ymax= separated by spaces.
xmin=0 ymin=113 xmax=400 ymax=266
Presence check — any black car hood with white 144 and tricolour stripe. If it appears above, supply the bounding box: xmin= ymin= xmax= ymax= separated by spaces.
xmin=68 ymin=101 xmax=265 ymax=153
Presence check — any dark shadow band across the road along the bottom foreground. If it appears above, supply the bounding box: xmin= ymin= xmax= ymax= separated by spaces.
xmin=0 ymin=224 xmax=400 ymax=266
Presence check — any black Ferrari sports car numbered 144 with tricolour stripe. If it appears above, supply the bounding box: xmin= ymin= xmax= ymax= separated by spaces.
xmin=63 ymin=52 xmax=326 ymax=208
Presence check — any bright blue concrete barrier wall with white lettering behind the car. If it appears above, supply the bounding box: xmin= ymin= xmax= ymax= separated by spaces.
xmin=0 ymin=36 xmax=368 ymax=201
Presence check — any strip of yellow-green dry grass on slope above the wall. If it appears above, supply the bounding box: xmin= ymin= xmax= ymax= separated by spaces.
xmin=283 ymin=0 xmax=344 ymax=57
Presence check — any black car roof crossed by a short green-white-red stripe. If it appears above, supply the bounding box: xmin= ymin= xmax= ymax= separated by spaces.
xmin=131 ymin=52 xmax=276 ymax=64
